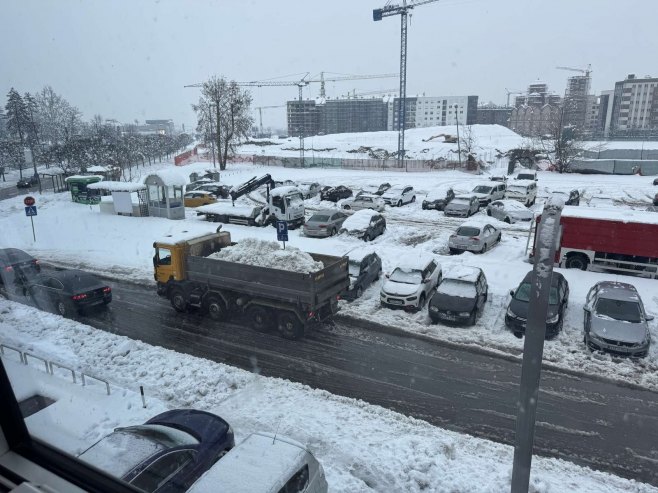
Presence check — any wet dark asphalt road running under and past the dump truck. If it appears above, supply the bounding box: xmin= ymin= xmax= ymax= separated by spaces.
xmin=78 ymin=276 xmax=658 ymax=485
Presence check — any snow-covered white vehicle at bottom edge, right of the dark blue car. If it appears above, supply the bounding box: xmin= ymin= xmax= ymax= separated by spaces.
xmin=188 ymin=432 xmax=328 ymax=493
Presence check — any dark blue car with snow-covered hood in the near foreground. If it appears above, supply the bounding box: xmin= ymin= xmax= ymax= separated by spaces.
xmin=79 ymin=409 xmax=235 ymax=493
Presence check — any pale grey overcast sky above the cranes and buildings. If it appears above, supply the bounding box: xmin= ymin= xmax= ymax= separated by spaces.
xmin=0 ymin=0 xmax=658 ymax=129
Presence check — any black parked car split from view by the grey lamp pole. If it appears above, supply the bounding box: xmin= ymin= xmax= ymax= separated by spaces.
xmin=505 ymin=271 xmax=569 ymax=339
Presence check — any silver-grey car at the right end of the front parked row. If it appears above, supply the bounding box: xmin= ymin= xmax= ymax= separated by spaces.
xmin=584 ymin=281 xmax=653 ymax=358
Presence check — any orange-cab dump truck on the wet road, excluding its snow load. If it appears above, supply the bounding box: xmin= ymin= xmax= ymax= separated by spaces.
xmin=153 ymin=226 xmax=350 ymax=339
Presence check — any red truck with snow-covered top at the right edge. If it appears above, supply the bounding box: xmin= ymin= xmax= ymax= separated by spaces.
xmin=533 ymin=206 xmax=658 ymax=279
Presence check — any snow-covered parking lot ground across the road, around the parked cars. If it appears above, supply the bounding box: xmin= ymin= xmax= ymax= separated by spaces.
xmin=0 ymin=163 xmax=658 ymax=390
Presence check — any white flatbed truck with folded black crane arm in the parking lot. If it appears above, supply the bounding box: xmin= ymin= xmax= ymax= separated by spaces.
xmin=196 ymin=174 xmax=305 ymax=229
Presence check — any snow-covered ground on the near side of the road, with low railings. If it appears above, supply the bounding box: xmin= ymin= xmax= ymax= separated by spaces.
xmin=0 ymin=300 xmax=658 ymax=493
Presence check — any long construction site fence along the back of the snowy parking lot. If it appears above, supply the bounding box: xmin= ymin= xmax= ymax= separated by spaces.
xmin=231 ymin=154 xmax=502 ymax=171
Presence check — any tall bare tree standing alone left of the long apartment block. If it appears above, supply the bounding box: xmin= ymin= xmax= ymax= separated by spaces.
xmin=192 ymin=77 xmax=254 ymax=170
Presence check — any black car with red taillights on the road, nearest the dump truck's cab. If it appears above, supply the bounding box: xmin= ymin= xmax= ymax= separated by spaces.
xmin=26 ymin=269 xmax=112 ymax=317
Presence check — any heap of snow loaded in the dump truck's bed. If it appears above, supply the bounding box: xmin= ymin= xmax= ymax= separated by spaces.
xmin=208 ymin=238 xmax=324 ymax=274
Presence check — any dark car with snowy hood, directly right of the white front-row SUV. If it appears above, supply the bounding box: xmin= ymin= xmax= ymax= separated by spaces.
xmin=428 ymin=266 xmax=489 ymax=325
